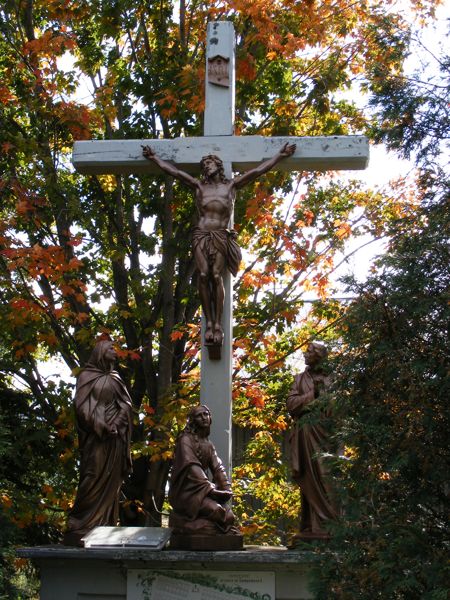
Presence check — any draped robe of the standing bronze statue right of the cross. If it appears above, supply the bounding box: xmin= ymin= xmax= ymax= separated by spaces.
xmin=286 ymin=367 xmax=336 ymax=533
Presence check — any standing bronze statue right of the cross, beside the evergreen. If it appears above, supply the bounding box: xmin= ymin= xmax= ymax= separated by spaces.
xmin=286 ymin=342 xmax=337 ymax=543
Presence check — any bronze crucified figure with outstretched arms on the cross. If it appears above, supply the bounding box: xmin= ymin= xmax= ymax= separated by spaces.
xmin=143 ymin=144 xmax=296 ymax=354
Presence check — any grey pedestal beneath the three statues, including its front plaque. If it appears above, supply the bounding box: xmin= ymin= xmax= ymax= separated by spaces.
xmin=17 ymin=546 xmax=314 ymax=600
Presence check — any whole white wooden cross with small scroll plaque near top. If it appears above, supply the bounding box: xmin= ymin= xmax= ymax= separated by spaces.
xmin=72 ymin=21 xmax=369 ymax=473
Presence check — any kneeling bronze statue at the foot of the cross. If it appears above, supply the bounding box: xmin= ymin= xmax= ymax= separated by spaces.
xmin=169 ymin=405 xmax=240 ymax=546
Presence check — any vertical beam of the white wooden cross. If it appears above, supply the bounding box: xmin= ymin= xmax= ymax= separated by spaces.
xmin=200 ymin=21 xmax=235 ymax=478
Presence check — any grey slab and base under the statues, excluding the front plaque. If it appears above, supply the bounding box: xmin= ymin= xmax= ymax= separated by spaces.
xmin=17 ymin=546 xmax=316 ymax=600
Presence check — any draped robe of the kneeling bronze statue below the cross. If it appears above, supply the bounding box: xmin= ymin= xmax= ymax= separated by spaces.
xmin=169 ymin=431 xmax=234 ymax=533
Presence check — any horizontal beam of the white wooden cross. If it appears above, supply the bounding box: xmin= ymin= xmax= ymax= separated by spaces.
xmin=72 ymin=135 xmax=369 ymax=175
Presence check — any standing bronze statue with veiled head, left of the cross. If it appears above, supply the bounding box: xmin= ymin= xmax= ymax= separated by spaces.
xmin=64 ymin=340 xmax=132 ymax=546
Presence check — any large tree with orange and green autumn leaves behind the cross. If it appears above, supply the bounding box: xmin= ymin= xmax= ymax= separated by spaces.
xmin=0 ymin=0 xmax=442 ymax=568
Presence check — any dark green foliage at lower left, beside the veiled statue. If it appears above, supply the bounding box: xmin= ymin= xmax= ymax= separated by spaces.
xmin=0 ymin=379 xmax=74 ymax=599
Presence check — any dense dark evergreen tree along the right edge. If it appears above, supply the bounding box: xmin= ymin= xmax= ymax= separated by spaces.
xmin=316 ymin=191 xmax=450 ymax=600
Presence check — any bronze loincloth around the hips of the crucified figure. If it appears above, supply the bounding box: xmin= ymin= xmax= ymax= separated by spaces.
xmin=192 ymin=227 xmax=242 ymax=276
